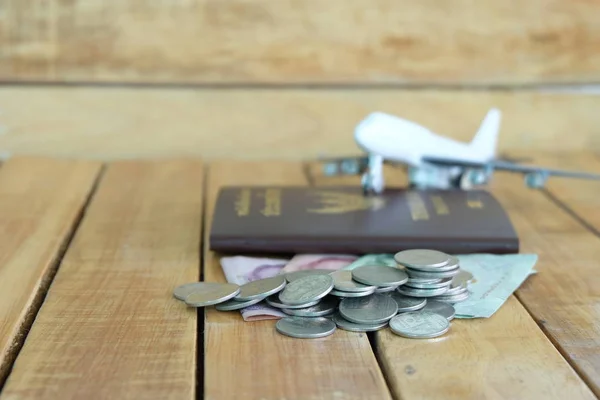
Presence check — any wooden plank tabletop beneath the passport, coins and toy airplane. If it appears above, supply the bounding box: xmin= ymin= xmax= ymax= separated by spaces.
xmin=0 ymin=153 xmax=600 ymax=400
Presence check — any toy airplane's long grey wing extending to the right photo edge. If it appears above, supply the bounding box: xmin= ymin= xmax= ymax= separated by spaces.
xmin=423 ymin=157 xmax=600 ymax=180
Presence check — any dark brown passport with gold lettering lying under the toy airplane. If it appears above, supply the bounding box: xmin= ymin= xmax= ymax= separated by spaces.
xmin=209 ymin=186 xmax=519 ymax=254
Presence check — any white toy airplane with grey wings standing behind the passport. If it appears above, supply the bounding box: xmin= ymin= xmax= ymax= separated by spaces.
xmin=324 ymin=109 xmax=600 ymax=194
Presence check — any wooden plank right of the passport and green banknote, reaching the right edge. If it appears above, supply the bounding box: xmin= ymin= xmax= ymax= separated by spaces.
xmin=493 ymin=156 xmax=600 ymax=396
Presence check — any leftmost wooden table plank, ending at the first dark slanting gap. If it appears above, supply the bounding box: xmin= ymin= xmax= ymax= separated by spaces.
xmin=0 ymin=157 xmax=100 ymax=386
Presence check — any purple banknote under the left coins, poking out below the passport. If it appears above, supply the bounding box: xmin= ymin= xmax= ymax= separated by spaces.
xmin=220 ymin=256 xmax=289 ymax=321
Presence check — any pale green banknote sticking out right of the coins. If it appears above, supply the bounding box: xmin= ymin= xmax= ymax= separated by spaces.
xmin=454 ymin=254 xmax=538 ymax=318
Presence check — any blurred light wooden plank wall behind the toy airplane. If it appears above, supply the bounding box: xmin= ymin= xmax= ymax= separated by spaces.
xmin=0 ymin=0 xmax=600 ymax=159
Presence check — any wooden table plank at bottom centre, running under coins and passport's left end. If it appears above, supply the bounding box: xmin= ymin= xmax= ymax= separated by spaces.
xmin=204 ymin=162 xmax=390 ymax=400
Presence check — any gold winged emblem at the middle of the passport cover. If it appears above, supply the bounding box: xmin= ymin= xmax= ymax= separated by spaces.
xmin=306 ymin=190 xmax=385 ymax=214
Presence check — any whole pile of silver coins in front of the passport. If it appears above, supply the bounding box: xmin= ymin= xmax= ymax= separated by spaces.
xmin=174 ymin=250 xmax=470 ymax=338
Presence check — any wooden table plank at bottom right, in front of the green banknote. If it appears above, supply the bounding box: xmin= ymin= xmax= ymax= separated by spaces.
xmin=312 ymin=162 xmax=594 ymax=399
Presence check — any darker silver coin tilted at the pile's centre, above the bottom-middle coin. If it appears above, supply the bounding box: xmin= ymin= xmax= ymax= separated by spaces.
xmin=339 ymin=294 xmax=398 ymax=324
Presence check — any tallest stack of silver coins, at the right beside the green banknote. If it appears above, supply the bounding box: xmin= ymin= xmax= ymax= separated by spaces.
xmin=394 ymin=249 xmax=469 ymax=303
